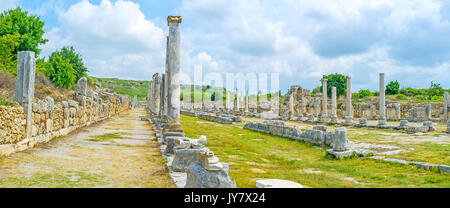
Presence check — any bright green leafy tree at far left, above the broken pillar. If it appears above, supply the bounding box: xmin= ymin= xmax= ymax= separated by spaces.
xmin=0 ymin=7 xmax=48 ymax=56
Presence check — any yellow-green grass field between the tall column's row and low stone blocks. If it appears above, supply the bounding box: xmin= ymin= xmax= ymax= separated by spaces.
xmin=181 ymin=115 xmax=450 ymax=188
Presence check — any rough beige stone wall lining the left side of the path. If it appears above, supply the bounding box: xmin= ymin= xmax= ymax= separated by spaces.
xmin=0 ymin=92 xmax=129 ymax=156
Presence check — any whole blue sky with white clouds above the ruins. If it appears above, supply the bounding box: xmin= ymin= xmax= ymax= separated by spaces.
xmin=0 ymin=0 xmax=450 ymax=91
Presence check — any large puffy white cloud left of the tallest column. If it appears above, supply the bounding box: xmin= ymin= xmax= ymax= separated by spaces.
xmin=43 ymin=0 xmax=165 ymax=80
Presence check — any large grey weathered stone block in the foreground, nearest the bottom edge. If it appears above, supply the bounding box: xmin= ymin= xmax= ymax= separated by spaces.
xmin=185 ymin=163 xmax=236 ymax=188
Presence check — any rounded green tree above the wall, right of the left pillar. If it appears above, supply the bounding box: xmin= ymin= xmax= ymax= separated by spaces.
xmin=45 ymin=54 xmax=76 ymax=88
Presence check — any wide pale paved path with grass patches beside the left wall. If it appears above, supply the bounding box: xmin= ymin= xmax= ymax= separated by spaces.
xmin=0 ymin=109 xmax=175 ymax=187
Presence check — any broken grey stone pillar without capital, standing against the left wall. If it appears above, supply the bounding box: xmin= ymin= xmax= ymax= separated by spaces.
xmin=13 ymin=51 xmax=36 ymax=138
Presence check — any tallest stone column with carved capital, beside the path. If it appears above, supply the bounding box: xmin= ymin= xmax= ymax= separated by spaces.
xmin=164 ymin=16 xmax=183 ymax=132
